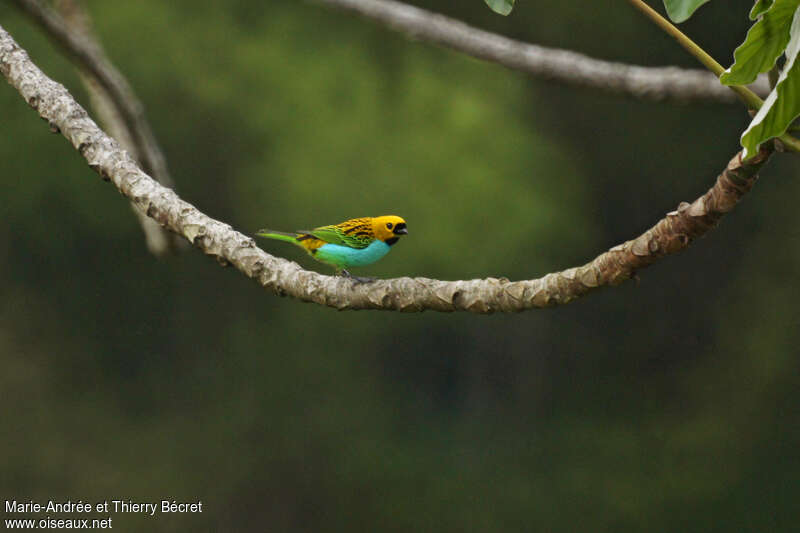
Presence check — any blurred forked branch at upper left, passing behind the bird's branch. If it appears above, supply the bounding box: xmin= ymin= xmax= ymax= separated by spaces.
xmin=13 ymin=0 xmax=182 ymax=256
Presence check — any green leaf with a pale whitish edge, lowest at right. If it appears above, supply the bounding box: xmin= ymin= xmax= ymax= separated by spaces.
xmin=742 ymin=9 xmax=800 ymax=159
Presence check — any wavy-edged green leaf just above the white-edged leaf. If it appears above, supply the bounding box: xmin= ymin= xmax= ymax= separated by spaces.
xmin=719 ymin=0 xmax=800 ymax=85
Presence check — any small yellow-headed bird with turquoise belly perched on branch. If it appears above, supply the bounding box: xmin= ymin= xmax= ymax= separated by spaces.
xmin=256 ymin=215 xmax=408 ymax=281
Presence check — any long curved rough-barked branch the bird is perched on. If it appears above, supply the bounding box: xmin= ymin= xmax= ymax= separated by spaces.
xmin=0 ymin=27 xmax=772 ymax=313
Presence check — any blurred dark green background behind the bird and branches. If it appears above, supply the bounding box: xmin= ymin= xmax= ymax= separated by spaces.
xmin=0 ymin=0 xmax=800 ymax=532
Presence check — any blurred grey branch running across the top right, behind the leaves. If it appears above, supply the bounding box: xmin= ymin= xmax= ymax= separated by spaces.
xmin=314 ymin=0 xmax=769 ymax=102
